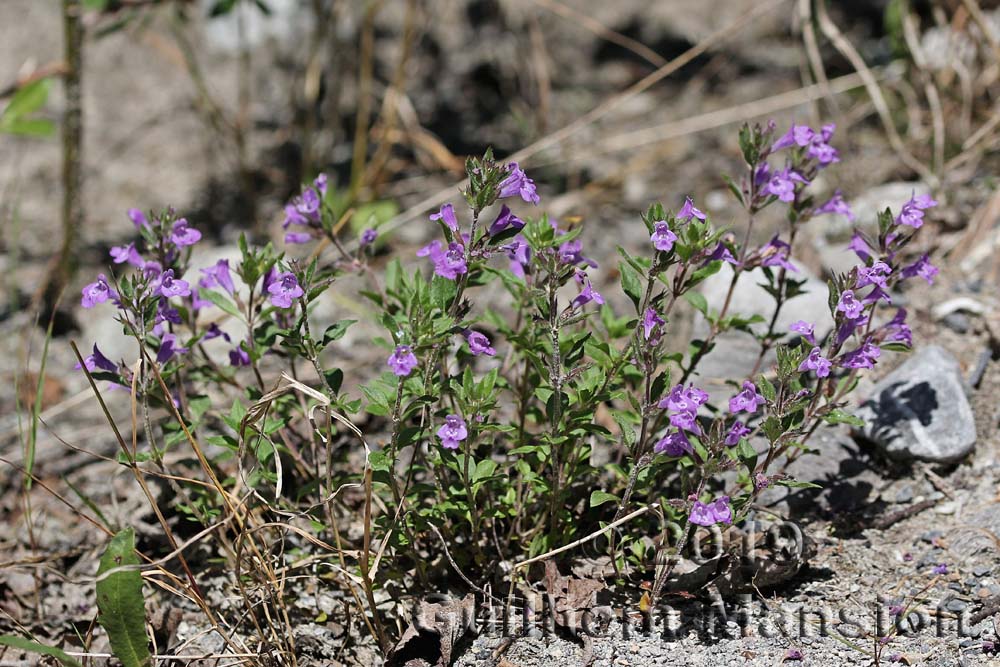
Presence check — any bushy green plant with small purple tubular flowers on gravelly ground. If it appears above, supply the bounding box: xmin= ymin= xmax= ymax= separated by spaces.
xmin=74 ymin=125 xmax=936 ymax=645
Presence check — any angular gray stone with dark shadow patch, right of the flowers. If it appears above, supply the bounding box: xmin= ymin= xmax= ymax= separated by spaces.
xmin=856 ymin=345 xmax=976 ymax=463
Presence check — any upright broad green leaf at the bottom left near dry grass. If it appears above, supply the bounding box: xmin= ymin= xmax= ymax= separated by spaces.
xmin=97 ymin=528 xmax=153 ymax=667
